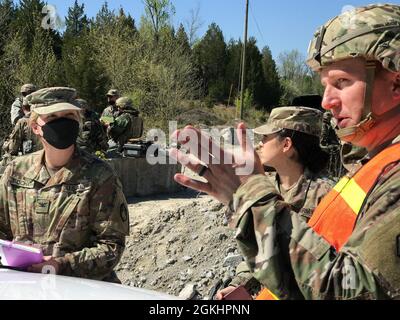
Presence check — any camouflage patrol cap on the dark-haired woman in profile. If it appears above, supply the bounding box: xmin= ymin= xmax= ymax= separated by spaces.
xmin=254 ymin=107 xmax=323 ymax=136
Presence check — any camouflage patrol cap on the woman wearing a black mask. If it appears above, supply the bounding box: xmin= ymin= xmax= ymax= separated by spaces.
xmin=26 ymin=87 xmax=81 ymax=115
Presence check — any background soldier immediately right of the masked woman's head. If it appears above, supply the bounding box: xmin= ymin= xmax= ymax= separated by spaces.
xmin=76 ymin=99 xmax=108 ymax=154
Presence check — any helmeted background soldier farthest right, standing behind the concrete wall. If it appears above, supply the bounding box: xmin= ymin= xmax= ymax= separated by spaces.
xmin=107 ymin=97 xmax=143 ymax=151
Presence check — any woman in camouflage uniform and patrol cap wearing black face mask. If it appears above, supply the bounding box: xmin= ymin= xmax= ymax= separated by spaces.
xmin=0 ymin=88 xmax=129 ymax=280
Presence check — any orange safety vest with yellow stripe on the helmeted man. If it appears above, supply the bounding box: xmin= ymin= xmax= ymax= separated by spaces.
xmin=256 ymin=144 xmax=400 ymax=300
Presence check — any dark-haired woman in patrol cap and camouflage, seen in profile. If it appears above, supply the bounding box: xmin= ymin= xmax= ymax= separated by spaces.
xmin=217 ymin=107 xmax=335 ymax=299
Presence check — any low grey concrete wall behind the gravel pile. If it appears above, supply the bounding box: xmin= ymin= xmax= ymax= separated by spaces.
xmin=107 ymin=158 xmax=181 ymax=197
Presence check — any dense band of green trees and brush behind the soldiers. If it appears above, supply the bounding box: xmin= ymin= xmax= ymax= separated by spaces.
xmin=0 ymin=0 xmax=322 ymax=138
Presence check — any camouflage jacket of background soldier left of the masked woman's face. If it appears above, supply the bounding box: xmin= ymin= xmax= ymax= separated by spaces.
xmin=3 ymin=116 xmax=43 ymax=156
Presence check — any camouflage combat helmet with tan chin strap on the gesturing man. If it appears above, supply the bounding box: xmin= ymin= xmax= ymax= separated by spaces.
xmin=307 ymin=4 xmax=400 ymax=142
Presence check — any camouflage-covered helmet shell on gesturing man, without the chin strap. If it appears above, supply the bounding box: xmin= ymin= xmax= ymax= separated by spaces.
xmin=307 ymin=4 xmax=400 ymax=72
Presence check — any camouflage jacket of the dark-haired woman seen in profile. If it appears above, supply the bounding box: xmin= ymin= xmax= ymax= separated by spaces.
xmin=230 ymin=169 xmax=335 ymax=291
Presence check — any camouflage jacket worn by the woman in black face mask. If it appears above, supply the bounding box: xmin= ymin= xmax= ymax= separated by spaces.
xmin=0 ymin=148 xmax=129 ymax=280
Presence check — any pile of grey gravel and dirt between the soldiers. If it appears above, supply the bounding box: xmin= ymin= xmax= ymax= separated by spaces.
xmin=116 ymin=190 xmax=243 ymax=300
